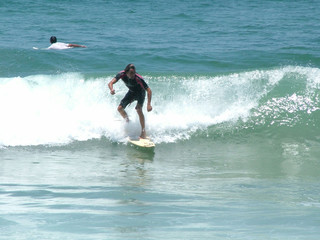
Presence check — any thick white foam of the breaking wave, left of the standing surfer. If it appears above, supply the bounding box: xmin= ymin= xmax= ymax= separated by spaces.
xmin=0 ymin=74 xmax=121 ymax=146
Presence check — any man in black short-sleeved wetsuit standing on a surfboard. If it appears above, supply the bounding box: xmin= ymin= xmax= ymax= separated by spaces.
xmin=108 ymin=64 xmax=152 ymax=138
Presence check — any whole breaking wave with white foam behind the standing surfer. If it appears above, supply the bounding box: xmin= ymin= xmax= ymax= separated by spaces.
xmin=0 ymin=66 xmax=320 ymax=146
